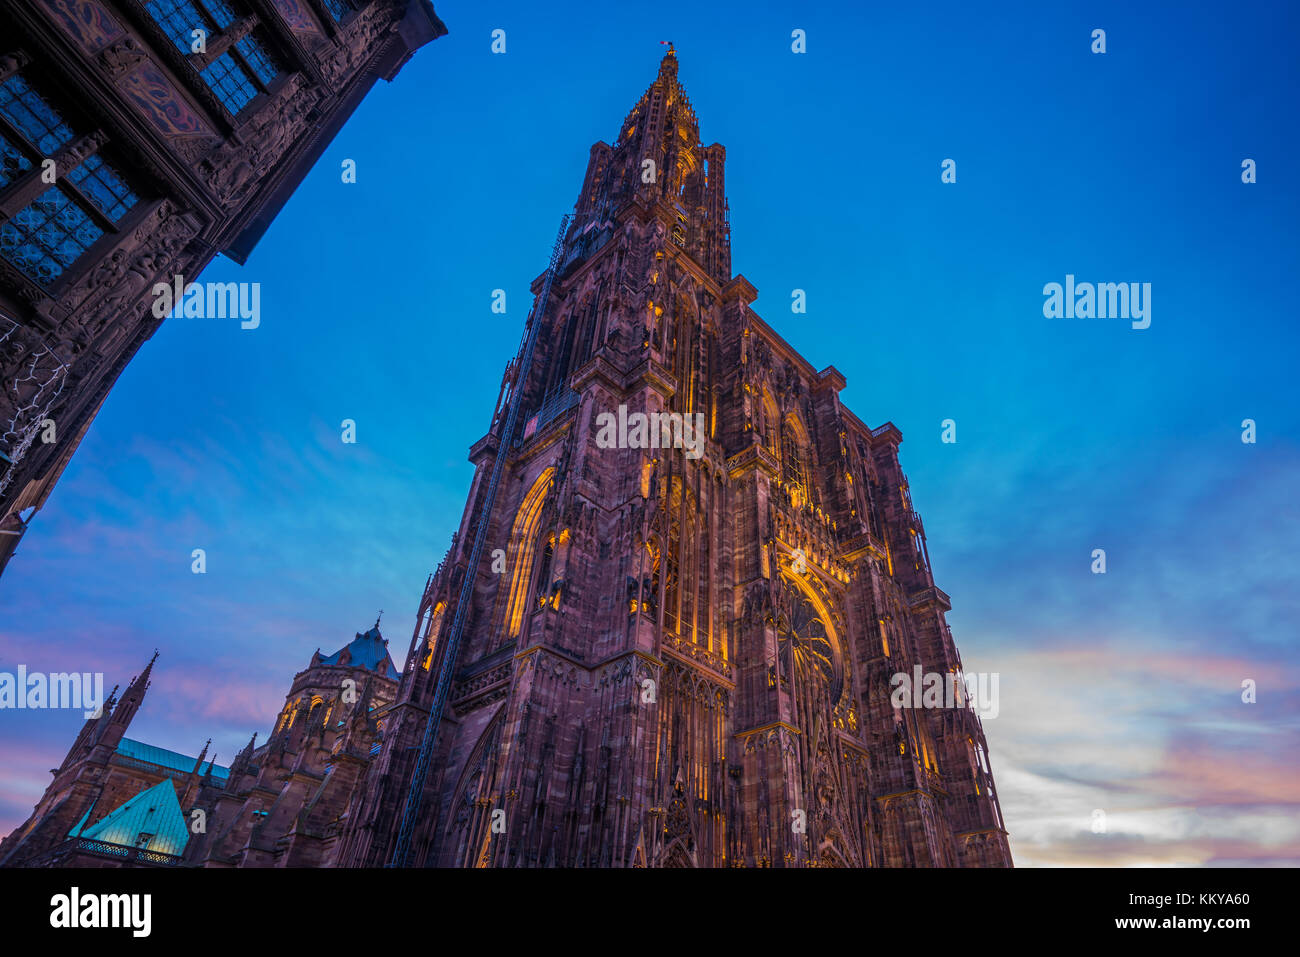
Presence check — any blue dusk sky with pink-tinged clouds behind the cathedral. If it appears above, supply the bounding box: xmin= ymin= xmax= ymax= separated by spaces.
xmin=0 ymin=0 xmax=1300 ymax=866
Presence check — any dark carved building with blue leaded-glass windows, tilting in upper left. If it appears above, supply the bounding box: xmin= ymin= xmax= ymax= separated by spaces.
xmin=0 ymin=0 xmax=446 ymax=570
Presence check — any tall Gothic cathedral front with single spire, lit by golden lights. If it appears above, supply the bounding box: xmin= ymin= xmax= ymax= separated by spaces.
xmin=339 ymin=48 xmax=1011 ymax=867
